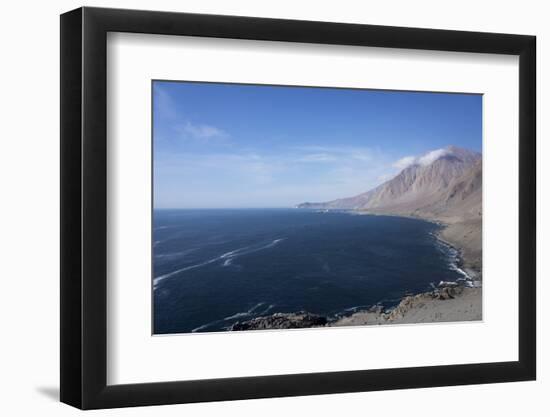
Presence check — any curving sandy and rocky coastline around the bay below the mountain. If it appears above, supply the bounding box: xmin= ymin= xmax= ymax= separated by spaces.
xmin=230 ymin=211 xmax=482 ymax=331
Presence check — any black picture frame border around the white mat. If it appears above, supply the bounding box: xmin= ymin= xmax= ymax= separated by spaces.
xmin=60 ymin=7 xmax=536 ymax=409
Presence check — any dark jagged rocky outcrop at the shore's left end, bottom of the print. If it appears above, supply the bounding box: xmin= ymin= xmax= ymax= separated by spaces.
xmin=231 ymin=311 xmax=327 ymax=330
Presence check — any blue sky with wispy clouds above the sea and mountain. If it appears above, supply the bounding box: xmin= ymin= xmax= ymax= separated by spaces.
xmin=153 ymin=81 xmax=482 ymax=208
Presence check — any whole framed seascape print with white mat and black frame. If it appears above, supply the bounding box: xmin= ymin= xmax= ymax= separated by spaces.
xmin=61 ymin=7 xmax=536 ymax=409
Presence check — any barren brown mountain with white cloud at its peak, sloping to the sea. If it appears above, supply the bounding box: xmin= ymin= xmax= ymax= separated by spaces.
xmin=297 ymin=146 xmax=482 ymax=270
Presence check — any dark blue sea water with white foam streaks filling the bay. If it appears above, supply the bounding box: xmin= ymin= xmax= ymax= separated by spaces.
xmin=153 ymin=209 xmax=461 ymax=334
